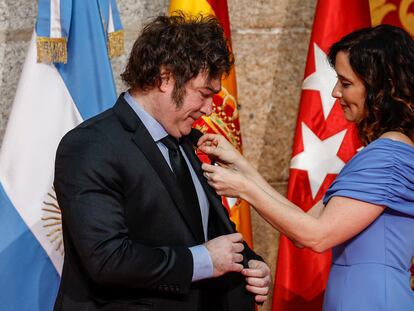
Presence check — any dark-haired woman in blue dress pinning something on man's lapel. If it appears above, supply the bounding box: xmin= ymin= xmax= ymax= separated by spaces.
xmin=199 ymin=25 xmax=414 ymax=311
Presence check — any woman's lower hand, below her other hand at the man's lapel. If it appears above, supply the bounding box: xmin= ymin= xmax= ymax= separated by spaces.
xmin=201 ymin=163 xmax=250 ymax=198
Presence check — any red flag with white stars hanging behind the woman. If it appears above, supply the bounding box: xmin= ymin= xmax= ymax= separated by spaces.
xmin=272 ymin=0 xmax=371 ymax=311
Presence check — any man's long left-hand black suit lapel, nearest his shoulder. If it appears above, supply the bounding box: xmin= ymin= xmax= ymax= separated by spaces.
xmin=114 ymin=95 xmax=204 ymax=244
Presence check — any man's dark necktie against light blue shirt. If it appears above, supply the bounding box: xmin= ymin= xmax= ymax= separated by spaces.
xmin=161 ymin=135 xmax=201 ymax=224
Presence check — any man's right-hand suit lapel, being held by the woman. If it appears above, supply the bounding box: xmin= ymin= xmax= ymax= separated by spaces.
xmin=183 ymin=136 xmax=235 ymax=233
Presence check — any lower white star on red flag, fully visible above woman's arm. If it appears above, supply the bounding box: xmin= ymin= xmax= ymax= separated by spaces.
xmin=290 ymin=122 xmax=346 ymax=198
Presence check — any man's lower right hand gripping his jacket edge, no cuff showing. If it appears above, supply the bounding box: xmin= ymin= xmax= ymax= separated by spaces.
xmin=242 ymin=260 xmax=271 ymax=303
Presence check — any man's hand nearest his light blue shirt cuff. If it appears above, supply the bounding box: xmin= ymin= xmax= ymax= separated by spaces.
xmin=204 ymin=233 xmax=244 ymax=277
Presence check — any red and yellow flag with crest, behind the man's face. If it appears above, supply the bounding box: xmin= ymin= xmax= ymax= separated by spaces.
xmin=170 ymin=0 xmax=253 ymax=247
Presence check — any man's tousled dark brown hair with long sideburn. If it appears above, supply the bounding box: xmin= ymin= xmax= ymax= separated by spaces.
xmin=121 ymin=13 xmax=234 ymax=106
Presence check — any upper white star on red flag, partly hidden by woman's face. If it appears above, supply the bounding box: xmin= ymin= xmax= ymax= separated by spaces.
xmin=302 ymin=43 xmax=336 ymax=120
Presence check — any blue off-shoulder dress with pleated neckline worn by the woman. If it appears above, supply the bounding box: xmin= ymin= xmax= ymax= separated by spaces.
xmin=323 ymin=138 xmax=414 ymax=311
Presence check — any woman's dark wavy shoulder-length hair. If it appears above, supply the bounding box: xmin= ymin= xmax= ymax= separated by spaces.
xmin=328 ymin=25 xmax=414 ymax=145
